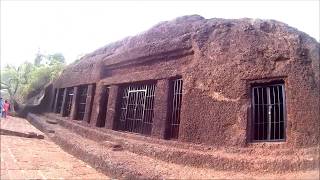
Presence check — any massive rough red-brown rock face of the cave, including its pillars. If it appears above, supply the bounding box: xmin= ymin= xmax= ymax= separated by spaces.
xmin=43 ymin=15 xmax=320 ymax=147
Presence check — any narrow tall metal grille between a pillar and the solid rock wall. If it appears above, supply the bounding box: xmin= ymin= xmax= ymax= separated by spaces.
xmin=170 ymin=78 xmax=183 ymax=139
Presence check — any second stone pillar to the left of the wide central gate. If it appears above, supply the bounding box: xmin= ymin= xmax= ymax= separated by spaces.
xmin=90 ymin=84 xmax=105 ymax=126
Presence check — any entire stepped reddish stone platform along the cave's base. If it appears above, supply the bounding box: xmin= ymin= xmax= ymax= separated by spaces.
xmin=28 ymin=114 xmax=319 ymax=179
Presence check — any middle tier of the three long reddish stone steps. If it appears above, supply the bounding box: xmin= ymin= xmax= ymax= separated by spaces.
xmin=28 ymin=112 xmax=319 ymax=173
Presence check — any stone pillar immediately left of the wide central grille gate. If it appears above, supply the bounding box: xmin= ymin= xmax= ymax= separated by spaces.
xmin=105 ymin=85 xmax=119 ymax=129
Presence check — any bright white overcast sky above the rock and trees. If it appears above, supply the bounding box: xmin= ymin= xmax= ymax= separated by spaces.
xmin=0 ymin=0 xmax=320 ymax=68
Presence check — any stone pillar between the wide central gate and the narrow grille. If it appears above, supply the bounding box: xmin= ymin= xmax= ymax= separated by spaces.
xmin=151 ymin=79 xmax=170 ymax=139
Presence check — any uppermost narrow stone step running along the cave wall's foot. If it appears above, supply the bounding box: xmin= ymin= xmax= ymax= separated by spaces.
xmin=44 ymin=113 xmax=319 ymax=158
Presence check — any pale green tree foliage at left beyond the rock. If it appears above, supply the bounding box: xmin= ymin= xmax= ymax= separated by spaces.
xmin=1 ymin=53 xmax=65 ymax=103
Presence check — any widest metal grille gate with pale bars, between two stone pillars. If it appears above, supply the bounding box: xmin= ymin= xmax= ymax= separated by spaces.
xmin=118 ymin=84 xmax=156 ymax=135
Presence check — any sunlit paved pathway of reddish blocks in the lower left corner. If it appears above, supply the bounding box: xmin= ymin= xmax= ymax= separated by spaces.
xmin=0 ymin=116 xmax=109 ymax=179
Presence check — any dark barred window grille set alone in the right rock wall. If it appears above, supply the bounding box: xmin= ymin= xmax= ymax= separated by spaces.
xmin=252 ymin=84 xmax=285 ymax=141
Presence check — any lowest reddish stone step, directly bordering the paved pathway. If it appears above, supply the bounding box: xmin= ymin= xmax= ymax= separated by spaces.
xmin=28 ymin=112 xmax=262 ymax=179
